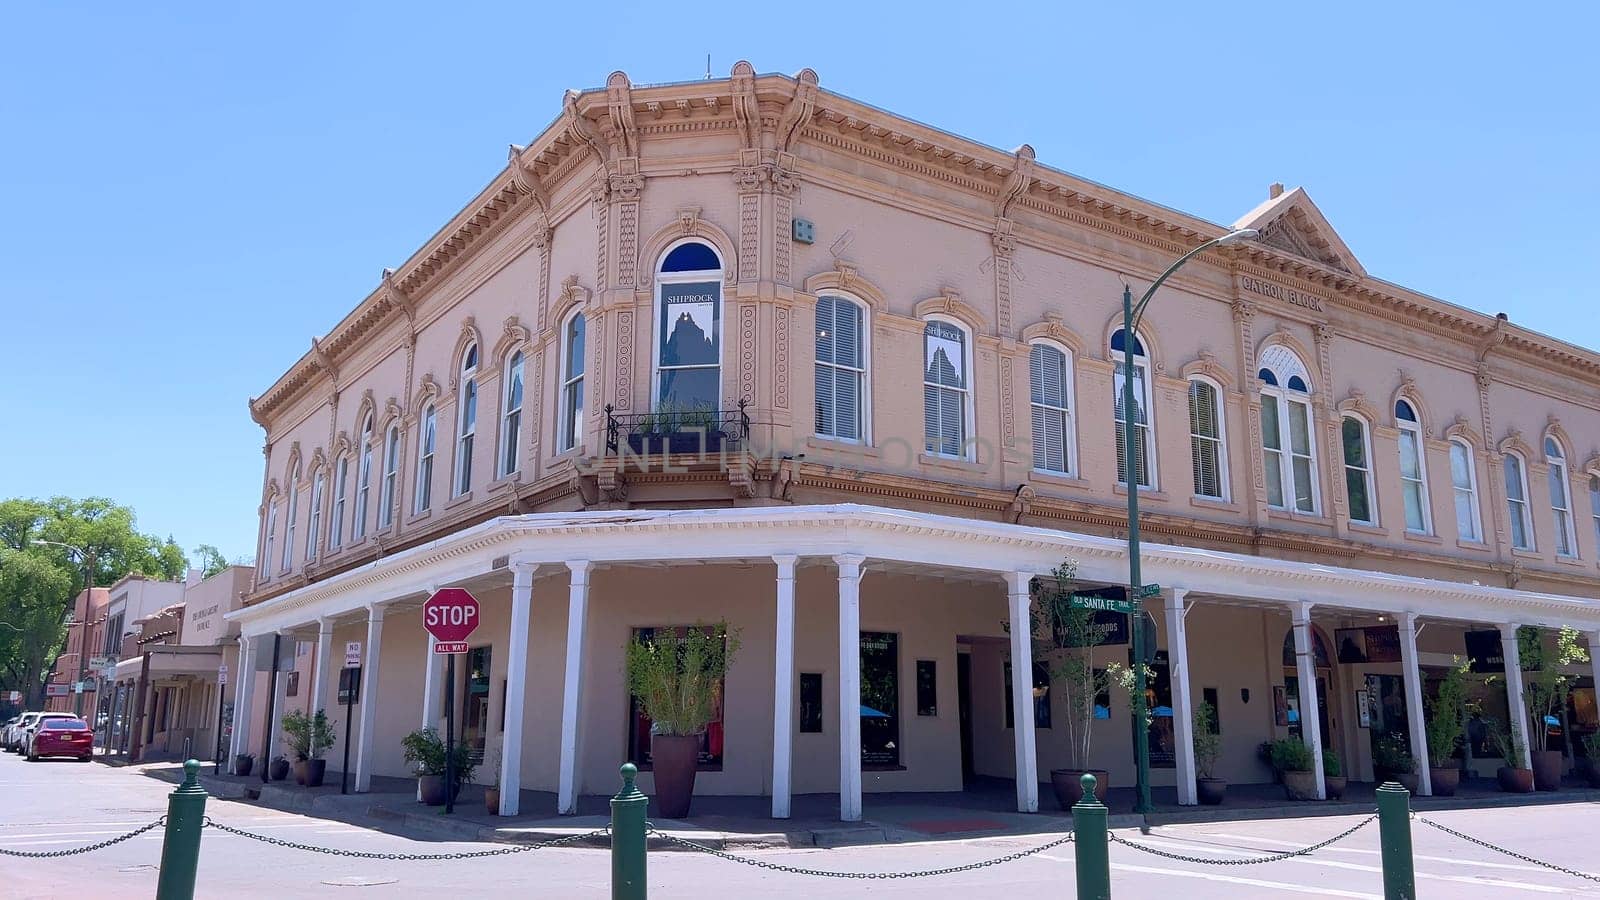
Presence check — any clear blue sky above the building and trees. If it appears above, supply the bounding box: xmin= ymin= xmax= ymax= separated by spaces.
xmin=0 ymin=0 xmax=1600 ymax=557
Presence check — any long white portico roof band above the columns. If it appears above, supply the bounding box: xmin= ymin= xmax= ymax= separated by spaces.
xmin=226 ymin=503 xmax=1600 ymax=634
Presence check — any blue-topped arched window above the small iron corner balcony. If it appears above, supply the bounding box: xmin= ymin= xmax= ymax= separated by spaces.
xmin=654 ymin=240 xmax=722 ymax=412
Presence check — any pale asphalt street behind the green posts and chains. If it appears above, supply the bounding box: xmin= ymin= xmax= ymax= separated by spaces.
xmin=0 ymin=754 xmax=1600 ymax=900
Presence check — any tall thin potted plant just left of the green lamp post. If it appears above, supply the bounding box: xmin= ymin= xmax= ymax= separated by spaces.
xmin=1002 ymin=559 xmax=1110 ymax=809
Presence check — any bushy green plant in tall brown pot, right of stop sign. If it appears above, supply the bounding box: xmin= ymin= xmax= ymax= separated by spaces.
xmin=627 ymin=621 xmax=739 ymax=818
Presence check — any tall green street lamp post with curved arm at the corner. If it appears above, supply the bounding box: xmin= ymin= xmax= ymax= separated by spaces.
xmin=1122 ymin=227 xmax=1259 ymax=815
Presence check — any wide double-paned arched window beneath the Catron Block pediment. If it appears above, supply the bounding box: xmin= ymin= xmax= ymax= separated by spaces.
xmin=1256 ymin=344 xmax=1318 ymax=512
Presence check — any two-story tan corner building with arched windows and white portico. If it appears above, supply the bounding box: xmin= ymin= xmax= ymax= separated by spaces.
xmin=229 ymin=62 xmax=1600 ymax=820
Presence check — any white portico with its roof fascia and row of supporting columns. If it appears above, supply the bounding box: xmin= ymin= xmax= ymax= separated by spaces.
xmin=229 ymin=504 xmax=1600 ymax=822
